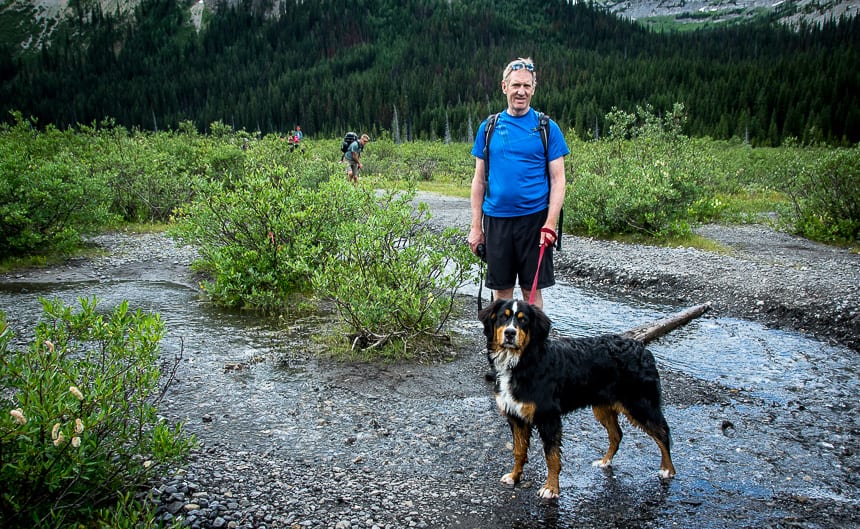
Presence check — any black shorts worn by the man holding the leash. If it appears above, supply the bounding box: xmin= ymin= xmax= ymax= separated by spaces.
xmin=484 ymin=210 xmax=555 ymax=290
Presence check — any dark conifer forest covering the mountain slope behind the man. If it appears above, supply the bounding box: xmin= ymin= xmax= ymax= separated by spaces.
xmin=0 ymin=0 xmax=860 ymax=145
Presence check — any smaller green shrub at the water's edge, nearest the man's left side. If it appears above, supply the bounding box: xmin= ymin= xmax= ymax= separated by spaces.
xmin=314 ymin=190 xmax=474 ymax=357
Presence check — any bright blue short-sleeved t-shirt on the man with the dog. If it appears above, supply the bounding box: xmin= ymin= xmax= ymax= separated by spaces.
xmin=472 ymin=108 xmax=570 ymax=217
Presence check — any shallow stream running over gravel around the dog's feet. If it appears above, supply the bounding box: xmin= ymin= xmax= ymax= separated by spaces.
xmin=0 ymin=281 xmax=860 ymax=528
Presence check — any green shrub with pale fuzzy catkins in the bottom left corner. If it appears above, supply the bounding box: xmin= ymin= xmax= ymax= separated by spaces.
xmin=0 ymin=298 xmax=194 ymax=527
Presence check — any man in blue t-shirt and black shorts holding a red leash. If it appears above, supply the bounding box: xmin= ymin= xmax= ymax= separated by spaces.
xmin=468 ymin=58 xmax=570 ymax=308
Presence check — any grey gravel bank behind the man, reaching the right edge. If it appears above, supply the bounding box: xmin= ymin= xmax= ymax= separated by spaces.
xmin=420 ymin=193 xmax=860 ymax=350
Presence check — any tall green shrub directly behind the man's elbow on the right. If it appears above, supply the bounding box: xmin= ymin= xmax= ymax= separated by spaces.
xmin=564 ymin=105 xmax=713 ymax=238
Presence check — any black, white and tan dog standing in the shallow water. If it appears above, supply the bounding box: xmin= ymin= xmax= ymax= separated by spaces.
xmin=478 ymin=299 xmax=675 ymax=499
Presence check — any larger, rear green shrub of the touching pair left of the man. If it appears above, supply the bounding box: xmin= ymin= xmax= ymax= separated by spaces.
xmin=171 ymin=162 xmax=359 ymax=312
